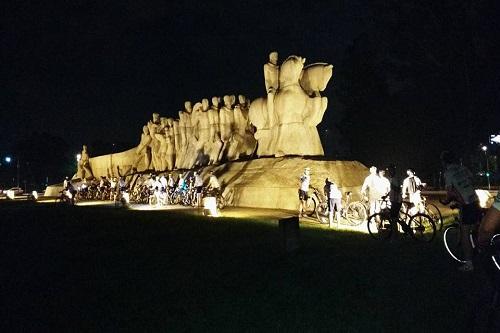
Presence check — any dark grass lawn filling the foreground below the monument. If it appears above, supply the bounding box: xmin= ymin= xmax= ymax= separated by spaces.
xmin=0 ymin=203 xmax=484 ymax=332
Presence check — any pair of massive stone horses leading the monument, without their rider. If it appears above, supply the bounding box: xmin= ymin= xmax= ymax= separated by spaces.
xmin=249 ymin=56 xmax=333 ymax=157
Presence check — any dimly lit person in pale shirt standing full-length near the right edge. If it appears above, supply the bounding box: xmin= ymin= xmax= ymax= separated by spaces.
xmin=439 ymin=151 xmax=481 ymax=271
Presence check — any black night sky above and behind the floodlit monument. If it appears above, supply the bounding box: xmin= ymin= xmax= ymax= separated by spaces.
xmin=0 ymin=0 xmax=500 ymax=176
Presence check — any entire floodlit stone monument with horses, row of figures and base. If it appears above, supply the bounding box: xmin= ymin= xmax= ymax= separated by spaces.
xmin=64 ymin=52 xmax=366 ymax=210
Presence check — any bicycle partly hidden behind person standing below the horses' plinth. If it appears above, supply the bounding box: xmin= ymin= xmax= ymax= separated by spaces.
xmin=316 ymin=192 xmax=367 ymax=226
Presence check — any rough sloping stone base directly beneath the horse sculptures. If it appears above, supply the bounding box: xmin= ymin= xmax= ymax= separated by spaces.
xmin=209 ymin=157 xmax=369 ymax=210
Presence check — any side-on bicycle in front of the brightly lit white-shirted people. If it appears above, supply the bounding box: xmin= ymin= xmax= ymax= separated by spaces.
xmin=367 ymin=196 xmax=436 ymax=243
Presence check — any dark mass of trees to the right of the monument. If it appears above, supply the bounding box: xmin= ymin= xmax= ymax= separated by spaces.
xmin=334 ymin=0 xmax=500 ymax=182
